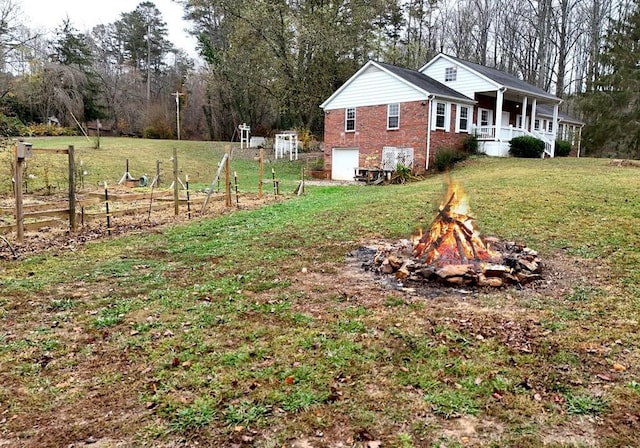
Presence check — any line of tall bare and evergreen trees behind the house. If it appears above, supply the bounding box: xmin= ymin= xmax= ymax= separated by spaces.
xmin=0 ymin=0 xmax=640 ymax=157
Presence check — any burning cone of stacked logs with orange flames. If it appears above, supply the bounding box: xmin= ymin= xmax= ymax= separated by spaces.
xmin=413 ymin=179 xmax=501 ymax=266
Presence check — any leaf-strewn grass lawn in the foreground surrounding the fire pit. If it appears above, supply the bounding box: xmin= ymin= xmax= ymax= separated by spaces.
xmin=0 ymin=140 xmax=640 ymax=448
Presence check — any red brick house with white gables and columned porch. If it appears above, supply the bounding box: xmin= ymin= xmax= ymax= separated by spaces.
xmin=320 ymin=54 xmax=581 ymax=180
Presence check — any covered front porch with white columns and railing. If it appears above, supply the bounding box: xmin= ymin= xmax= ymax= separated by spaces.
xmin=472 ymin=87 xmax=560 ymax=157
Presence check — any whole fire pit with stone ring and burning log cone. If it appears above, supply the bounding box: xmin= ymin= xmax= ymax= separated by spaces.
xmin=365 ymin=180 xmax=542 ymax=287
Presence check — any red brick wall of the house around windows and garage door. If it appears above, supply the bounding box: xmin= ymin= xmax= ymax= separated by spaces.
xmin=324 ymin=101 xmax=468 ymax=173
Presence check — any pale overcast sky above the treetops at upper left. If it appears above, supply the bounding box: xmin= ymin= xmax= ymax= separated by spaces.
xmin=16 ymin=0 xmax=196 ymax=56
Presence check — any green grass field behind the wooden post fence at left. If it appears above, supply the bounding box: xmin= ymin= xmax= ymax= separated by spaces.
xmin=0 ymin=137 xmax=302 ymax=194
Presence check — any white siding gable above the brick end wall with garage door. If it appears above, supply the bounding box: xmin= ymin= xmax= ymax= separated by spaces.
xmin=325 ymin=66 xmax=426 ymax=110
